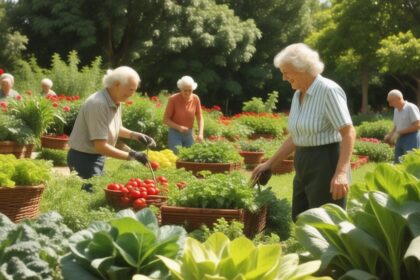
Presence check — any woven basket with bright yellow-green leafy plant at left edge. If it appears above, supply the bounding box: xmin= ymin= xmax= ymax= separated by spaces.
xmin=0 ymin=155 xmax=51 ymax=222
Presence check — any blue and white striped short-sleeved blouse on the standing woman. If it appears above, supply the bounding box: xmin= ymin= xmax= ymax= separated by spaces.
xmin=288 ymin=75 xmax=352 ymax=147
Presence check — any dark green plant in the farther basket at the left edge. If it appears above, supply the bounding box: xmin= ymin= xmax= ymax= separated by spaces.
xmin=0 ymin=112 xmax=35 ymax=144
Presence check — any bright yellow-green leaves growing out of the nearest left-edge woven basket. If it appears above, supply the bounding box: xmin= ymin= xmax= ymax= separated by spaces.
xmin=0 ymin=155 xmax=51 ymax=187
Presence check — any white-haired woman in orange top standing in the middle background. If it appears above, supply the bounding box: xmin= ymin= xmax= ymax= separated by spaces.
xmin=163 ymin=76 xmax=204 ymax=154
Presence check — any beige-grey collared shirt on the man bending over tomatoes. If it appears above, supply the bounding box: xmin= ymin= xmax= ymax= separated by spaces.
xmin=69 ymin=89 xmax=122 ymax=154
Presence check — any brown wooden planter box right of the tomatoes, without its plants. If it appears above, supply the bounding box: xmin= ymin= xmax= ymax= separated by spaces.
xmin=160 ymin=205 xmax=267 ymax=238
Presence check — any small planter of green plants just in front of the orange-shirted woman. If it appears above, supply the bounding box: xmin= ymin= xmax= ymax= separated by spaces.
xmin=176 ymin=141 xmax=242 ymax=174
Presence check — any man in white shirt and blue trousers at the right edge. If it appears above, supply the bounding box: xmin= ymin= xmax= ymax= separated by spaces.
xmin=384 ymin=89 xmax=420 ymax=163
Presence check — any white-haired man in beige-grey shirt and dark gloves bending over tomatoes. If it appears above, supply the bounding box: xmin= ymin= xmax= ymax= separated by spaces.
xmin=67 ymin=66 xmax=156 ymax=191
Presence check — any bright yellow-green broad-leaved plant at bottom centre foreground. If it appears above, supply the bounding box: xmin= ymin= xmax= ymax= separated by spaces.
xmin=159 ymin=232 xmax=329 ymax=280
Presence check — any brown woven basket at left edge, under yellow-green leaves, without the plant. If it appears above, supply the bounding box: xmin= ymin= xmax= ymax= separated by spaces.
xmin=0 ymin=185 xmax=44 ymax=223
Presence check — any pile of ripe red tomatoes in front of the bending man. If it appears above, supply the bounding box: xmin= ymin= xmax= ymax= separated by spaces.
xmin=106 ymin=176 xmax=169 ymax=209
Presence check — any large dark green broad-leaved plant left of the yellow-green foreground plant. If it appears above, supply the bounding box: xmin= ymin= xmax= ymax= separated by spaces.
xmin=61 ymin=208 xmax=186 ymax=279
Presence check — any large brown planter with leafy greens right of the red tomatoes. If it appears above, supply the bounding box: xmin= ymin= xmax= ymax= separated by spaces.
xmin=161 ymin=172 xmax=270 ymax=236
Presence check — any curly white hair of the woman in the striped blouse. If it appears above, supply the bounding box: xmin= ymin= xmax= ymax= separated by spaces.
xmin=274 ymin=43 xmax=324 ymax=76
